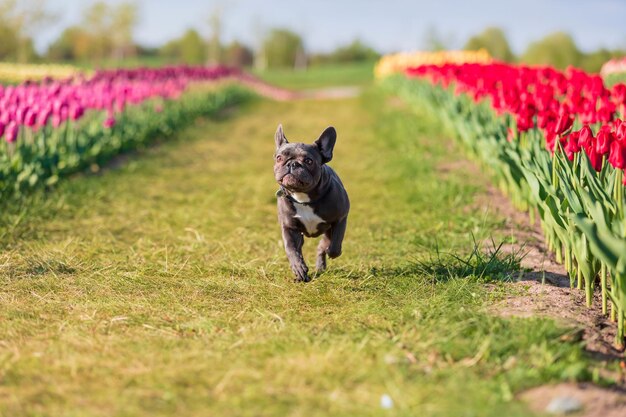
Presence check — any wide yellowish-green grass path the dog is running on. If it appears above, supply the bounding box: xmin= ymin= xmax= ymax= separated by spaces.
xmin=0 ymin=93 xmax=588 ymax=416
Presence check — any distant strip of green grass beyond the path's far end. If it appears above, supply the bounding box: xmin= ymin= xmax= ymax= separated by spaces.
xmin=254 ymin=62 xmax=374 ymax=90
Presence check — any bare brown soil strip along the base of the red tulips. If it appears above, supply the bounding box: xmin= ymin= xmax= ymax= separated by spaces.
xmin=438 ymin=150 xmax=626 ymax=417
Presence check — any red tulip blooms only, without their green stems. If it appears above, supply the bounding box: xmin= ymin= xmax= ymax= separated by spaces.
xmin=406 ymin=63 xmax=626 ymax=176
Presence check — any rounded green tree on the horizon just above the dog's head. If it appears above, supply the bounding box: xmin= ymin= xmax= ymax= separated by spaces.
xmin=262 ymin=29 xmax=305 ymax=68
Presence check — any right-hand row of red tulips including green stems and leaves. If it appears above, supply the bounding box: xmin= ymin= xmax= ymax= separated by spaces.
xmin=388 ymin=63 xmax=626 ymax=346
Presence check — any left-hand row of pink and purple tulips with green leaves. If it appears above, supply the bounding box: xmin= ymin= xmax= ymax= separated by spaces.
xmin=0 ymin=66 xmax=249 ymax=198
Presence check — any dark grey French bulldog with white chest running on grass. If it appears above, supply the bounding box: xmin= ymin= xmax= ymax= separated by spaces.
xmin=274 ymin=125 xmax=350 ymax=282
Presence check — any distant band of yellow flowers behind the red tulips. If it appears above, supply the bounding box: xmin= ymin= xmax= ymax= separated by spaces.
xmin=374 ymin=49 xmax=492 ymax=78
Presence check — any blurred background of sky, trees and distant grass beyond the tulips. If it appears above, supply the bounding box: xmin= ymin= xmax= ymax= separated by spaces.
xmin=0 ymin=0 xmax=626 ymax=84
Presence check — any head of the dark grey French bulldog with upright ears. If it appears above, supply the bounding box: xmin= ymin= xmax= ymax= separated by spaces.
xmin=274 ymin=125 xmax=337 ymax=193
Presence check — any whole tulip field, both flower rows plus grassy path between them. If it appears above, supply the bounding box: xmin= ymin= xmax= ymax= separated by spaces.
xmin=0 ymin=57 xmax=626 ymax=417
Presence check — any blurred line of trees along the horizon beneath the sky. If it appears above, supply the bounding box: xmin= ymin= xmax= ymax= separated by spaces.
xmin=0 ymin=0 xmax=626 ymax=72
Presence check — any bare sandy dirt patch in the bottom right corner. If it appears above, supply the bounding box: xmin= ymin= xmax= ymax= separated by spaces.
xmin=520 ymin=384 xmax=626 ymax=417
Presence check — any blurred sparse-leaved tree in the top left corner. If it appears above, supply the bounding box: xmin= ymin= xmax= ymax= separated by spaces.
xmin=0 ymin=0 xmax=55 ymax=62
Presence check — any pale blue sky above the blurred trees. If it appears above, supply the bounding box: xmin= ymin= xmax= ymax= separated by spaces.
xmin=36 ymin=0 xmax=626 ymax=53
